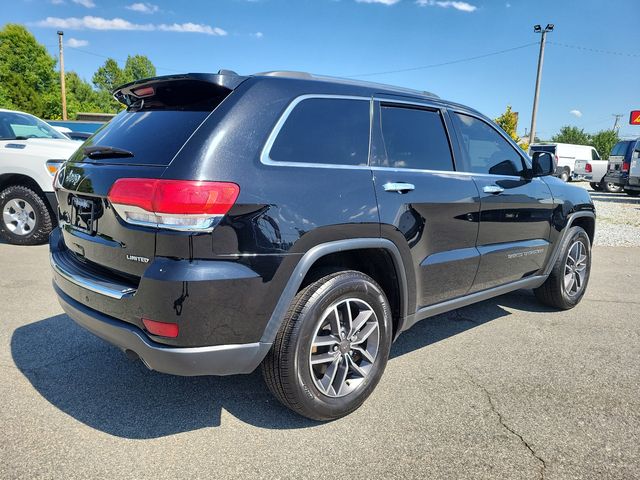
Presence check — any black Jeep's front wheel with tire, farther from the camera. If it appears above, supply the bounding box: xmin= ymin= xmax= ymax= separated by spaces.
xmin=533 ymin=227 xmax=591 ymax=310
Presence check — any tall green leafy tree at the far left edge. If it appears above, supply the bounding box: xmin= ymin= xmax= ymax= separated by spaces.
xmin=0 ymin=24 xmax=56 ymax=116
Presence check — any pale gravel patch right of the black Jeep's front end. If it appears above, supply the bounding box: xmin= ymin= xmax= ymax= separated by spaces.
xmin=572 ymin=182 xmax=640 ymax=247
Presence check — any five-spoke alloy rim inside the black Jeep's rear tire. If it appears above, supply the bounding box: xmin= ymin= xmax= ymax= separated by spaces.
xmin=309 ymin=298 xmax=380 ymax=398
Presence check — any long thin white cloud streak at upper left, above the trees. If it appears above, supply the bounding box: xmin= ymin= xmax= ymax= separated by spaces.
xmin=35 ymin=16 xmax=227 ymax=36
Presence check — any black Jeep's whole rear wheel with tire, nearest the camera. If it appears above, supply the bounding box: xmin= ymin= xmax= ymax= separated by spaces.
xmin=262 ymin=270 xmax=392 ymax=421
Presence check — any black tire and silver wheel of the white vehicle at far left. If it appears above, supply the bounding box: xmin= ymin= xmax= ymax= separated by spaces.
xmin=0 ymin=185 xmax=53 ymax=245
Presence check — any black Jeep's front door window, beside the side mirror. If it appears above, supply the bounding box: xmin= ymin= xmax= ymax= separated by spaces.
xmin=452 ymin=113 xmax=524 ymax=176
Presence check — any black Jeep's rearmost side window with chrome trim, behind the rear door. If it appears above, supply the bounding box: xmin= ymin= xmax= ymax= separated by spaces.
xmin=269 ymin=98 xmax=369 ymax=165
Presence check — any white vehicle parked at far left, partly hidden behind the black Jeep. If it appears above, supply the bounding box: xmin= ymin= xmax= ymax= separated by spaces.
xmin=0 ymin=109 xmax=80 ymax=245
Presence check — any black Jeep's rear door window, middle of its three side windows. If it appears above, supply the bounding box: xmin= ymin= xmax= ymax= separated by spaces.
xmin=377 ymin=104 xmax=453 ymax=171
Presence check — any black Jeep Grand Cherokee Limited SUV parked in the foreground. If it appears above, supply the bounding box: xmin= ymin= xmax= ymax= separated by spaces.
xmin=50 ymin=71 xmax=595 ymax=420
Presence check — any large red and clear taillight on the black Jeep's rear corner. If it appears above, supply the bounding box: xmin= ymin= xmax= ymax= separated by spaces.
xmin=107 ymin=178 xmax=240 ymax=230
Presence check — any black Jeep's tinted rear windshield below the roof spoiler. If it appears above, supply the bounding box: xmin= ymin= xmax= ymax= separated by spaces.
xmin=74 ymin=81 xmax=230 ymax=165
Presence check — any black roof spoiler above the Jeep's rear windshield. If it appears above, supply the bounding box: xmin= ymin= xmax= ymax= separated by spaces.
xmin=113 ymin=70 xmax=248 ymax=107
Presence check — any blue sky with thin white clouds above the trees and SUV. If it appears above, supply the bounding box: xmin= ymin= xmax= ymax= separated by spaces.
xmin=5 ymin=0 xmax=640 ymax=138
